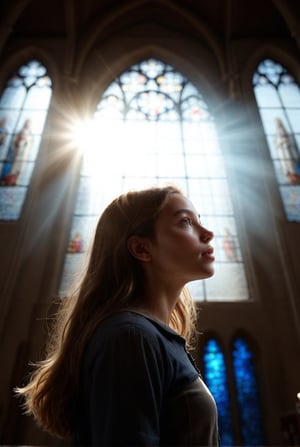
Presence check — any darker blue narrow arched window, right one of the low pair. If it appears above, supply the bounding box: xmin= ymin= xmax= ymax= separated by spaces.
xmin=232 ymin=338 xmax=265 ymax=446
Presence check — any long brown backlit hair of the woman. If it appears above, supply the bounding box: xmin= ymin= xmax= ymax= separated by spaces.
xmin=16 ymin=186 xmax=196 ymax=437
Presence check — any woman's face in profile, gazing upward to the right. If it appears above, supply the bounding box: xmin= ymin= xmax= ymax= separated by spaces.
xmin=151 ymin=193 xmax=214 ymax=283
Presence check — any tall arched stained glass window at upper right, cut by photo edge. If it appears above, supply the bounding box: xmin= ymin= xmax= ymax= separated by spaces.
xmin=253 ymin=59 xmax=300 ymax=222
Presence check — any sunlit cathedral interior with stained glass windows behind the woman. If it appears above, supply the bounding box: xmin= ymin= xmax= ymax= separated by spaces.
xmin=0 ymin=0 xmax=300 ymax=446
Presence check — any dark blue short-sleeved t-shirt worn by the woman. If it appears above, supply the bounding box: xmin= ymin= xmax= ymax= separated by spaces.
xmin=73 ymin=312 xmax=218 ymax=446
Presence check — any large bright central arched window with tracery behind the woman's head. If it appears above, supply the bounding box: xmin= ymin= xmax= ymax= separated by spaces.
xmin=62 ymin=59 xmax=248 ymax=301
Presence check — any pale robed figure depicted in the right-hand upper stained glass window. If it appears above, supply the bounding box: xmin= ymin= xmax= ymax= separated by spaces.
xmin=274 ymin=118 xmax=300 ymax=183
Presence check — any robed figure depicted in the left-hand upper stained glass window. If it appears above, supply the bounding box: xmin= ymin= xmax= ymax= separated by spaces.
xmin=0 ymin=119 xmax=32 ymax=186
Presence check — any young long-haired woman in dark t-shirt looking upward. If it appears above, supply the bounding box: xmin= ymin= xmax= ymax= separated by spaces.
xmin=17 ymin=187 xmax=218 ymax=446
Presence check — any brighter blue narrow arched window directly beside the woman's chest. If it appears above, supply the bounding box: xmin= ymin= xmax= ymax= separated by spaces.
xmin=203 ymin=339 xmax=234 ymax=446
